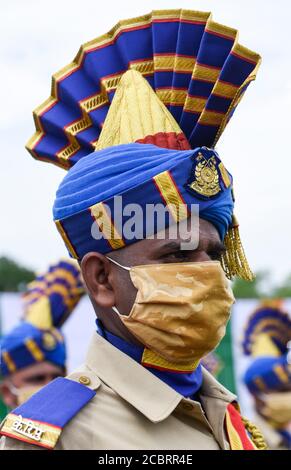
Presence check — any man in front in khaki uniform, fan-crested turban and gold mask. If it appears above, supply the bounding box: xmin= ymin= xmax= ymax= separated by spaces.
xmin=1 ymin=10 xmax=265 ymax=450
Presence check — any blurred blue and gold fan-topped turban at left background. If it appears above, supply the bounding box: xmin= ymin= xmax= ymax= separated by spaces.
xmin=0 ymin=260 xmax=84 ymax=377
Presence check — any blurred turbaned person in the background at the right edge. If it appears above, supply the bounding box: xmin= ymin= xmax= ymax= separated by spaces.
xmin=243 ymin=300 xmax=291 ymax=449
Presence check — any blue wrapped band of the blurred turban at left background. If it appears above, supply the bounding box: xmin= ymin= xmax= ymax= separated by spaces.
xmin=0 ymin=322 xmax=66 ymax=376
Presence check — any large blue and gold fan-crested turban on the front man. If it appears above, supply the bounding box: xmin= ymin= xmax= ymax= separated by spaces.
xmin=27 ymin=10 xmax=260 ymax=279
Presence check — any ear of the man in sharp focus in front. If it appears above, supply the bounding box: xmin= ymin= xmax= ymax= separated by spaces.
xmin=81 ymin=252 xmax=115 ymax=308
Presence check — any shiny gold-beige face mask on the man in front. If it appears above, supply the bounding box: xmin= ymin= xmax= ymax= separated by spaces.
xmin=109 ymin=258 xmax=234 ymax=364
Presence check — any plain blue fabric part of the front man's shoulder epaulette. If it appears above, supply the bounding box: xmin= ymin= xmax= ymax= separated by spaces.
xmin=12 ymin=377 xmax=96 ymax=428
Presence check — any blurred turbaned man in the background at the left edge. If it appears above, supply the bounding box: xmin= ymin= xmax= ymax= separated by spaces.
xmin=0 ymin=260 xmax=84 ymax=409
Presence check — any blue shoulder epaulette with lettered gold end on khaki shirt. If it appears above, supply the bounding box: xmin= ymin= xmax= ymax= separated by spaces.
xmin=0 ymin=377 xmax=96 ymax=449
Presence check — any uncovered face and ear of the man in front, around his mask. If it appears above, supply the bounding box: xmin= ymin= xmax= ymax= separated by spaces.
xmin=81 ymin=219 xmax=225 ymax=343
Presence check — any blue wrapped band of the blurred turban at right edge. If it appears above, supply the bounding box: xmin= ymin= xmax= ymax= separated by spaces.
xmin=244 ymin=355 xmax=291 ymax=394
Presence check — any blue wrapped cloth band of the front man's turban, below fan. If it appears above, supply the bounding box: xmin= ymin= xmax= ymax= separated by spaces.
xmin=53 ymin=143 xmax=233 ymax=258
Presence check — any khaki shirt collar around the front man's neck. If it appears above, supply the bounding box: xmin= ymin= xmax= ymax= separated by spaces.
xmin=86 ymin=333 xmax=235 ymax=423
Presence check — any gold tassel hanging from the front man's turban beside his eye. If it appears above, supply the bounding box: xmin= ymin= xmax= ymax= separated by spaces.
xmin=221 ymin=216 xmax=255 ymax=281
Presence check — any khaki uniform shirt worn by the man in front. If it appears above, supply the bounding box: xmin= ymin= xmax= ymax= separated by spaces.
xmin=1 ymin=334 xmax=236 ymax=450
